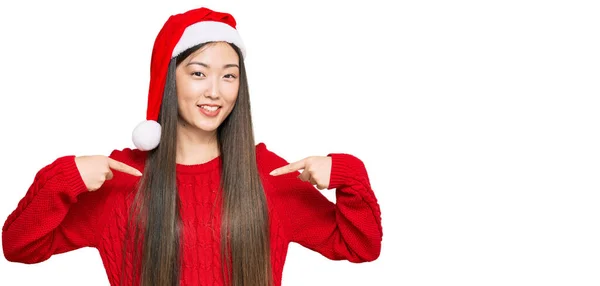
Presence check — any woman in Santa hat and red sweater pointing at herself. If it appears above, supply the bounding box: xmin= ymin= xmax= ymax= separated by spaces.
xmin=2 ymin=8 xmax=382 ymax=285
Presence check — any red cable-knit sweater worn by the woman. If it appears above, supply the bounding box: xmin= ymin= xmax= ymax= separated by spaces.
xmin=2 ymin=143 xmax=382 ymax=285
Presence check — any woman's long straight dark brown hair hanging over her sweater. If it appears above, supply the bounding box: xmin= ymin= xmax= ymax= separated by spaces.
xmin=121 ymin=44 xmax=273 ymax=286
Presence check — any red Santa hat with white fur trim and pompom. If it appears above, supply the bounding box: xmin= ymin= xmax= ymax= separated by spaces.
xmin=132 ymin=8 xmax=246 ymax=151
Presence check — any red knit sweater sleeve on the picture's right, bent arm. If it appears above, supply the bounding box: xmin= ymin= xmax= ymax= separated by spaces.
xmin=256 ymin=144 xmax=383 ymax=263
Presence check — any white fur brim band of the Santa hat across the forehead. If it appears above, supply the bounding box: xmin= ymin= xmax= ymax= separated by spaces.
xmin=171 ymin=21 xmax=246 ymax=58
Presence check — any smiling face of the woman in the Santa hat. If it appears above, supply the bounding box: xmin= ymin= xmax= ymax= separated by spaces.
xmin=176 ymin=42 xmax=240 ymax=131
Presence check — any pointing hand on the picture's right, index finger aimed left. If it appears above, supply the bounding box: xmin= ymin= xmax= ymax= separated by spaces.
xmin=270 ymin=156 xmax=331 ymax=190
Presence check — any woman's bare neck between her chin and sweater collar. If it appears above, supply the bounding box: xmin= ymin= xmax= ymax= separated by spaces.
xmin=176 ymin=116 xmax=220 ymax=165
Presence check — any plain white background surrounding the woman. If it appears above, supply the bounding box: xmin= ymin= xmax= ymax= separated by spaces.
xmin=0 ymin=0 xmax=600 ymax=286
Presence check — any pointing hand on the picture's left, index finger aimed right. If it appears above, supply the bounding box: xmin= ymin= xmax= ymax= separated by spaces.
xmin=75 ymin=155 xmax=142 ymax=192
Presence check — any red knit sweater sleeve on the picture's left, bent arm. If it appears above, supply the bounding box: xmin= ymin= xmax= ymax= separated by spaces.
xmin=2 ymin=153 xmax=119 ymax=264
